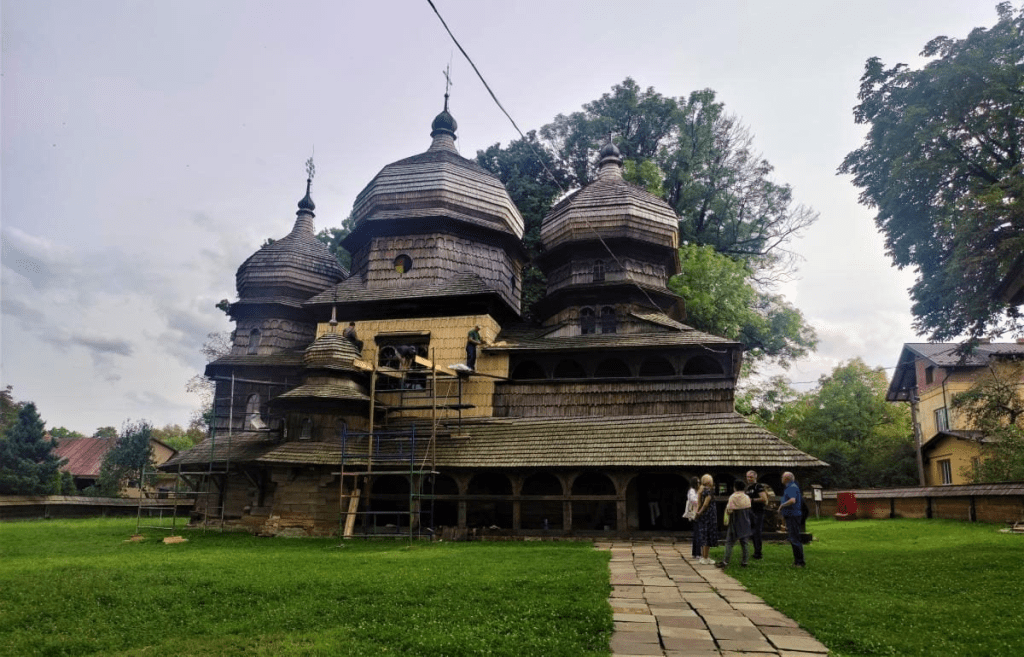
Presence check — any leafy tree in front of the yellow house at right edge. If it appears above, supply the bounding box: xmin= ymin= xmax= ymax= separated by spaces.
xmin=950 ymin=361 xmax=1024 ymax=483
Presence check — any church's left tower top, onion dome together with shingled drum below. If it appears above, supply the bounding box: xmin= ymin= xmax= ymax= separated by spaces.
xmin=228 ymin=176 xmax=347 ymax=354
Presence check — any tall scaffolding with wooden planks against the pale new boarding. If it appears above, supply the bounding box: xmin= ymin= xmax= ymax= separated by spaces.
xmin=336 ymin=347 xmax=473 ymax=540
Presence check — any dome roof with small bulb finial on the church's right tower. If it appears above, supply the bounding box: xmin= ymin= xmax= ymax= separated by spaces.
xmin=541 ymin=140 xmax=679 ymax=251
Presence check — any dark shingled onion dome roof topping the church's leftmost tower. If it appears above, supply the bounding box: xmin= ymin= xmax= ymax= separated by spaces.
xmin=234 ymin=179 xmax=346 ymax=301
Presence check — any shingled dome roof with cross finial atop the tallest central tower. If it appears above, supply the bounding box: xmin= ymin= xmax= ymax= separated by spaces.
xmin=352 ymin=102 xmax=523 ymax=239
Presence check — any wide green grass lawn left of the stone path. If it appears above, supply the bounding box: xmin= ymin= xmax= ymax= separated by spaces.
xmin=0 ymin=519 xmax=612 ymax=657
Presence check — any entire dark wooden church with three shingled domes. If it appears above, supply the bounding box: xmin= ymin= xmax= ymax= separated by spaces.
xmin=164 ymin=102 xmax=825 ymax=536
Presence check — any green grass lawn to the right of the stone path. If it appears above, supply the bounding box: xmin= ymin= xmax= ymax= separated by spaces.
xmin=713 ymin=520 xmax=1024 ymax=657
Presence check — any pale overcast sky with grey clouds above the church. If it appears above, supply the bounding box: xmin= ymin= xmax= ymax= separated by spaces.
xmin=0 ymin=0 xmax=996 ymax=435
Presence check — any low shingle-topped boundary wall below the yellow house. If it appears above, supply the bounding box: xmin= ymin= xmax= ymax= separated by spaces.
xmin=805 ymin=482 xmax=1024 ymax=523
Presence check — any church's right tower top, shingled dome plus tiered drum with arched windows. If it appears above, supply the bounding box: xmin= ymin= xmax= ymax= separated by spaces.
xmin=539 ymin=139 xmax=681 ymax=323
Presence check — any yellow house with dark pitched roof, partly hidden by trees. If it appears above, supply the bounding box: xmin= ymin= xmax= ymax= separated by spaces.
xmin=886 ymin=341 xmax=1024 ymax=486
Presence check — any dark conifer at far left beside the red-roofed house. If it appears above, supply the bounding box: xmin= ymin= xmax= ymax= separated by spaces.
xmin=0 ymin=401 xmax=67 ymax=495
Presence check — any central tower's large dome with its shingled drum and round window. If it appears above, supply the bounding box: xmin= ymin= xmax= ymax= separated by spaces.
xmin=319 ymin=94 xmax=524 ymax=316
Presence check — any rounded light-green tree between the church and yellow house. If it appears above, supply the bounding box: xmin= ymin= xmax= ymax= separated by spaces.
xmin=779 ymin=358 xmax=918 ymax=488
